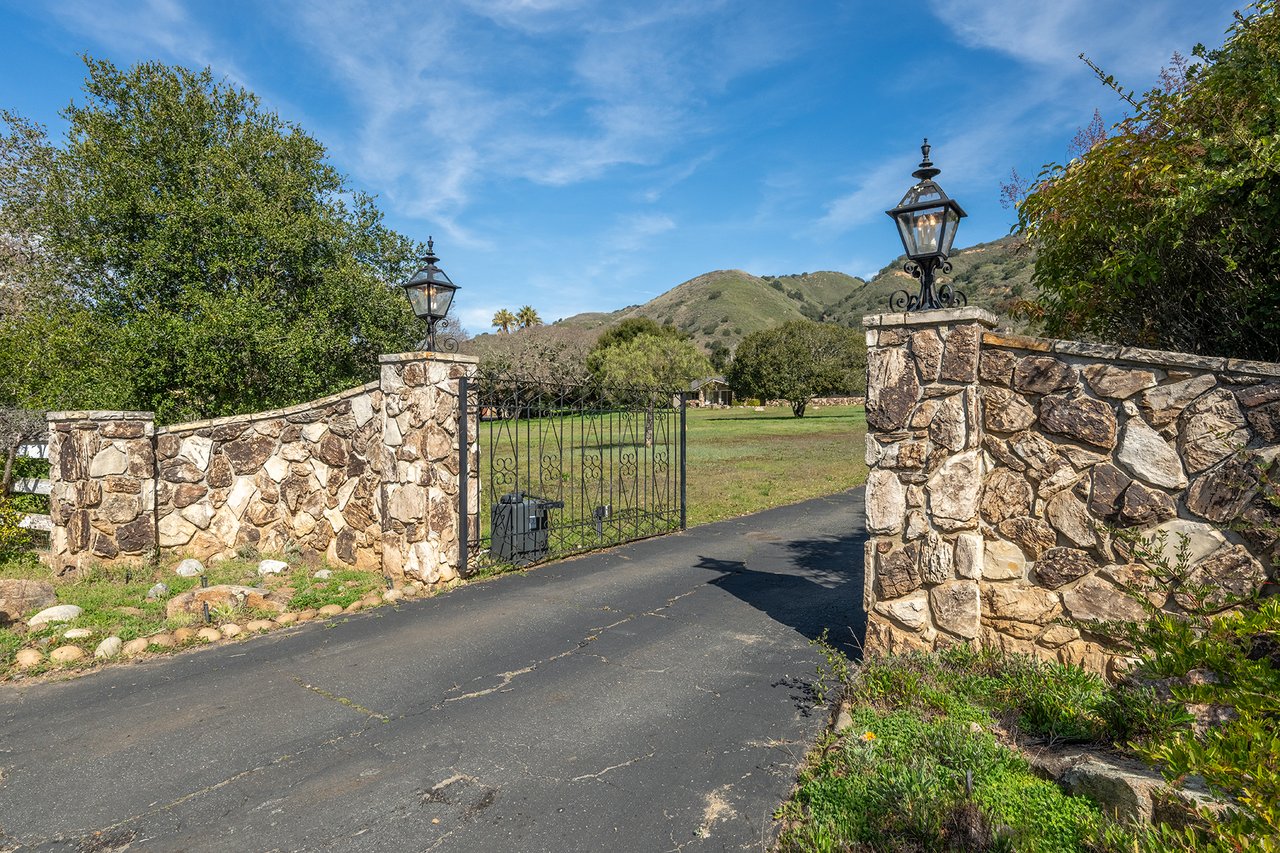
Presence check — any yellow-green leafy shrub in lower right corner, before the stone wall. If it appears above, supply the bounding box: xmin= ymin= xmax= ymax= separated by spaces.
xmin=1100 ymin=517 xmax=1280 ymax=850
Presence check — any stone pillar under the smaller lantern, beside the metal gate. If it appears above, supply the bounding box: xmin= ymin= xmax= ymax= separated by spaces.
xmin=380 ymin=352 xmax=479 ymax=584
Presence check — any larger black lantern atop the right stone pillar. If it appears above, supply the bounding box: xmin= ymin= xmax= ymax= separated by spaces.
xmin=884 ymin=140 xmax=968 ymax=311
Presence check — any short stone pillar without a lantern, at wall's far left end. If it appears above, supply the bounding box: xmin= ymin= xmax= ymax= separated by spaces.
xmin=49 ymin=411 xmax=156 ymax=574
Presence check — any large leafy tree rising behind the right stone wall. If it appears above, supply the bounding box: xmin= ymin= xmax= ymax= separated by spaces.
xmin=1019 ymin=0 xmax=1280 ymax=361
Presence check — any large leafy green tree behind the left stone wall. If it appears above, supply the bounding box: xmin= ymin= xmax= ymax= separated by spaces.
xmin=0 ymin=59 xmax=421 ymax=421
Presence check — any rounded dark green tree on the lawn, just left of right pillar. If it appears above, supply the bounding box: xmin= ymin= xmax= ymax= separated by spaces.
xmin=727 ymin=320 xmax=867 ymax=418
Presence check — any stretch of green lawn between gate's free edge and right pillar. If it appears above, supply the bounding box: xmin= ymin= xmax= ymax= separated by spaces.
xmin=687 ymin=406 xmax=867 ymax=526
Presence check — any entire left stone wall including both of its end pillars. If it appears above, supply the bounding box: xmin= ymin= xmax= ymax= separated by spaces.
xmin=49 ymin=352 xmax=479 ymax=583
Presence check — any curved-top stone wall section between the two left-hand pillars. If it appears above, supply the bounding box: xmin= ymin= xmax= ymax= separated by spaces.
xmin=156 ymin=382 xmax=384 ymax=569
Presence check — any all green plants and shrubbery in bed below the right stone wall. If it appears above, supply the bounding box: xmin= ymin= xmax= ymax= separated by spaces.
xmin=780 ymin=550 xmax=1280 ymax=853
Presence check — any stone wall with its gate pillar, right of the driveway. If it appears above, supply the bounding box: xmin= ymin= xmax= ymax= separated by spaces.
xmin=864 ymin=309 xmax=1280 ymax=672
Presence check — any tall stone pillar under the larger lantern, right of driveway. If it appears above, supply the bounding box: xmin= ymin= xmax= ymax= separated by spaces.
xmin=863 ymin=307 xmax=997 ymax=653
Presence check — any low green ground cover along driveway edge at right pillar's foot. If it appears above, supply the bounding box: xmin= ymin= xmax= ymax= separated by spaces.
xmin=778 ymin=649 xmax=1108 ymax=853
